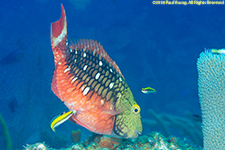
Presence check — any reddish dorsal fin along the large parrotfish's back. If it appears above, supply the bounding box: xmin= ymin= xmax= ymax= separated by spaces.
xmin=71 ymin=39 xmax=123 ymax=77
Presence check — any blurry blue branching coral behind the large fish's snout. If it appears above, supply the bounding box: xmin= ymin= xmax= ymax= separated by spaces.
xmin=142 ymin=109 xmax=203 ymax=146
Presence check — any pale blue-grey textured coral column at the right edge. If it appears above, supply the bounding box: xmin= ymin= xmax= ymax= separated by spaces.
xmin=197 ymin=51 xmax=225 ymax=150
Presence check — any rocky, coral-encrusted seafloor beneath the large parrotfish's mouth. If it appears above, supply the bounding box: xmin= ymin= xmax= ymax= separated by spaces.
xmin=24 ymin=132 xmax=201 ymax=150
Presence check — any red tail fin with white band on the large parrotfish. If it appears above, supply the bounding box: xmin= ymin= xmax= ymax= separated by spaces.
xmin=51 ymin=4 xmax=67 ymax=64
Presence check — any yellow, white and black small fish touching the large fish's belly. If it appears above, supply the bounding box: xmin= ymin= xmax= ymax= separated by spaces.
xmin=50 ymin=111 xmax=76 ymax=132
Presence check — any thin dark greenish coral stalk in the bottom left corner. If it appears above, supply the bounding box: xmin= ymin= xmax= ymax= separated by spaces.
xmin=0 ymin=114 xmax=12 ymax=150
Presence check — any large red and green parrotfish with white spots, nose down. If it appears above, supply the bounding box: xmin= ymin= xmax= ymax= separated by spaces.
xmin=51 ymin=5 xmax=142 ymax=138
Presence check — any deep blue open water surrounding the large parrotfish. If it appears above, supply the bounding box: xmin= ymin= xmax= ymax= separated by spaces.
xmin=0 ymin=0 xmax=225 ymax=149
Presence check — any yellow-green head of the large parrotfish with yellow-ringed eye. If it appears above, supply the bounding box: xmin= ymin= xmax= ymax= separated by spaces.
xmin=113 ymin=89 xmax=142 ymax=139
